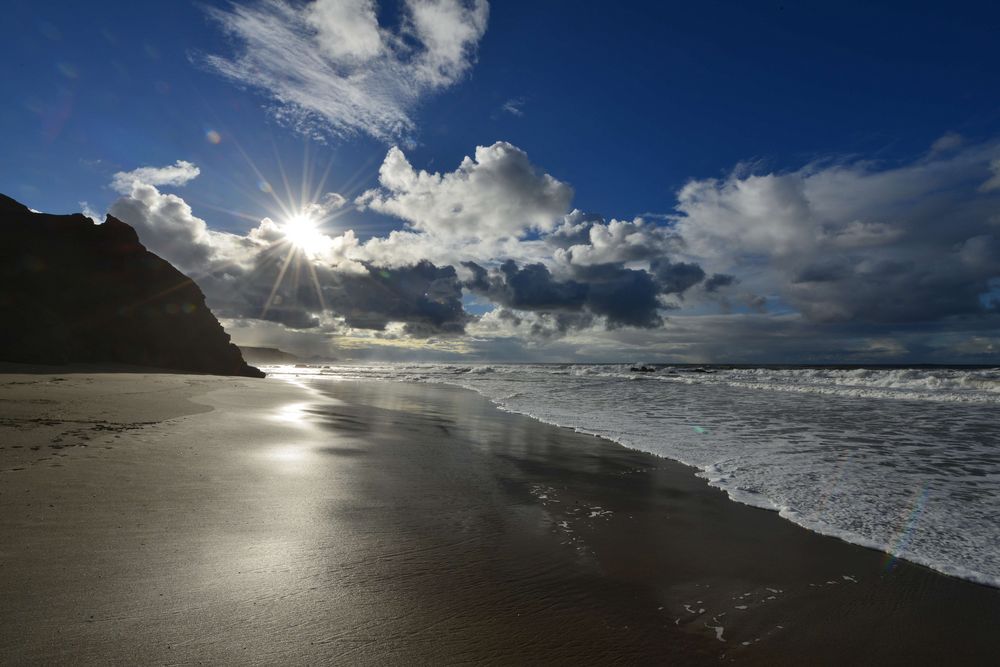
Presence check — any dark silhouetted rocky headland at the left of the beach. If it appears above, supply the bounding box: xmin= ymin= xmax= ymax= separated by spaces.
xmin=0 ymin=195 xmax=264 ymax=377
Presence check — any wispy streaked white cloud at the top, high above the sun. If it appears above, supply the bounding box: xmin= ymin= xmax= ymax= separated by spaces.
xmin=205 ymin=0 xmax=489 ymax=141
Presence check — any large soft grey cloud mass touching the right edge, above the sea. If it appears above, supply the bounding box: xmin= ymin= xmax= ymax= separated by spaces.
xmin=674 ymin=145 xmax=1000 ymax=324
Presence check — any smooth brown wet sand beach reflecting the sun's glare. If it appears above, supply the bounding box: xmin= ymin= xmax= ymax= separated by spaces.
xmin=0 ymin=373 xmax=1000 ymax=664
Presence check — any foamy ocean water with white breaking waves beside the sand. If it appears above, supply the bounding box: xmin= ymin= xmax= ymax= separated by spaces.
xmin=265 ymin=364 xmax=1000 ymax=587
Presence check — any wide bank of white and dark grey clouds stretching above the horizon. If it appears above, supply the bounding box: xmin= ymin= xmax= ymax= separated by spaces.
xmin=101 ymin=136 xmax=1000 ymax=362
